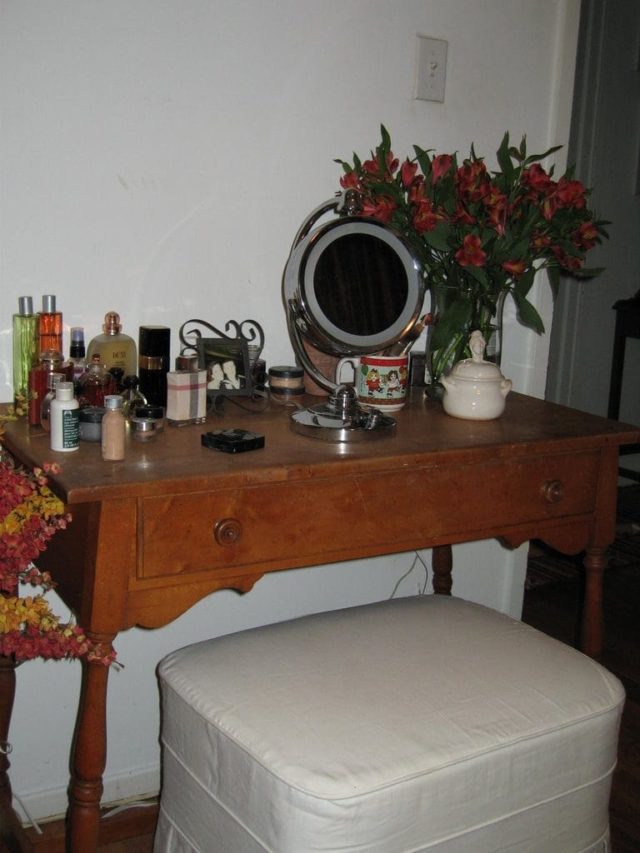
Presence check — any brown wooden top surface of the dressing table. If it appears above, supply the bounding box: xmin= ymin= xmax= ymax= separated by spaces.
xmin=3 ymin=388 xmax=640 ymax=505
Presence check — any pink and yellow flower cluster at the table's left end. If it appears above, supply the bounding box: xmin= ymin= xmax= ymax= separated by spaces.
xmin=0 ymin=412 xmax=115 ymax=666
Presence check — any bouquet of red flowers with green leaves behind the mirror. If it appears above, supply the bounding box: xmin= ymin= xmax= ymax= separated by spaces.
xmin=336 ymin=126 xmax=608 ymax=379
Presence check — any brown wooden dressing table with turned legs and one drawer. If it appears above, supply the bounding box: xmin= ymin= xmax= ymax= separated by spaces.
xmin=0 ymin=389 xmax=640 ymax=853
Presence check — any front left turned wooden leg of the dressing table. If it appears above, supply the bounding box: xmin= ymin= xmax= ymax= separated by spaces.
xmin=67 ymin=638 xmax=113 ymax=853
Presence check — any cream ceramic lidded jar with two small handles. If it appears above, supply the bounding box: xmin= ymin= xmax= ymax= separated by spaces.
xmin=441 ymin=332 xmax=512 ymax=421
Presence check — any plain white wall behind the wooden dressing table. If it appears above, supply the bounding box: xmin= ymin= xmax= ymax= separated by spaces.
xmin=0 ymin=0 xmax=579 ymax=816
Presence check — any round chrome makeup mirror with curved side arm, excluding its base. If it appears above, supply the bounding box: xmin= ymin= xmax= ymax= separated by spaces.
xmin=283 ymin=191 xmax=424 ymax=392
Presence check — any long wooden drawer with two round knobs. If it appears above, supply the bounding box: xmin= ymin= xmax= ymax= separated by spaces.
xmin=138 ymin=451 xmax=599 ymax=578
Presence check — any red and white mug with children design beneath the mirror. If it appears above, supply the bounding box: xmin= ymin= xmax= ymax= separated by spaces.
xmin=336 ymin=355 xmax=409 ymax=412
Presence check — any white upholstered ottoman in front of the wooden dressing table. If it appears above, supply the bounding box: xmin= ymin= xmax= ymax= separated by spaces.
xmin=155 ymin=596 xmax=624 ymax=853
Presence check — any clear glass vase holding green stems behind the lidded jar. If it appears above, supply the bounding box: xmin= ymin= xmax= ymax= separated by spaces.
xmin=425 ymin=282 xmax=506 ymax=399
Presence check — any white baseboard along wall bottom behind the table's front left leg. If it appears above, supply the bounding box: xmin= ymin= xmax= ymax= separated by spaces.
xmin=13 ymin=765 xmax=160 ymax=825
